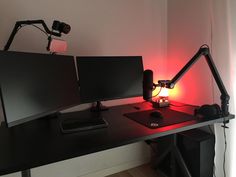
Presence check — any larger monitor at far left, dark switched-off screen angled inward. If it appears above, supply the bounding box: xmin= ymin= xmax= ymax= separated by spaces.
xmin=0 ymin=51 xmax=79 ymax=127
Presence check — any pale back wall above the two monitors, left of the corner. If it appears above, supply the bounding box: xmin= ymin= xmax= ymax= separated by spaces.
xmin=0 ymin=0 xmax=166 ymax=79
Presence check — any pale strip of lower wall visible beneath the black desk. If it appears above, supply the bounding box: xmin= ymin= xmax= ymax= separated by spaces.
xmin=28 ymin=142 xmax=151 ymax=177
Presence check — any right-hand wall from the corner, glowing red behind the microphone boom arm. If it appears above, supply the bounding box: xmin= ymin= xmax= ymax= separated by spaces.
xmin=167 ymin=0 xmax=213 ymax=104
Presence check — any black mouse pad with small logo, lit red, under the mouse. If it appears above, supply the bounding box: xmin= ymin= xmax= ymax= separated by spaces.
xmin=124 ymin=108 xmax=196 ymax=129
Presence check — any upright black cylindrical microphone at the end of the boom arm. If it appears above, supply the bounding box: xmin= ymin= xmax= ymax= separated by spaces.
xmin=143 ymin=69 xmax=153 ymax=101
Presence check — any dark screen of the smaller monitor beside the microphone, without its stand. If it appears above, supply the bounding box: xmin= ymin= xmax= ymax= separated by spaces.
xmin=76 ymin=56 xmax=143 ymax=103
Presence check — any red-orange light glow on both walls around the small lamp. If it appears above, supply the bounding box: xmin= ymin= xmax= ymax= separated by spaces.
xmin=145 ymin=48 xmax=212 ymax=104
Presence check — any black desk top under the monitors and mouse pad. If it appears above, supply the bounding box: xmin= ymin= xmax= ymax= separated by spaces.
xmin=0 ymin=103 xmax=234 ymax=177
